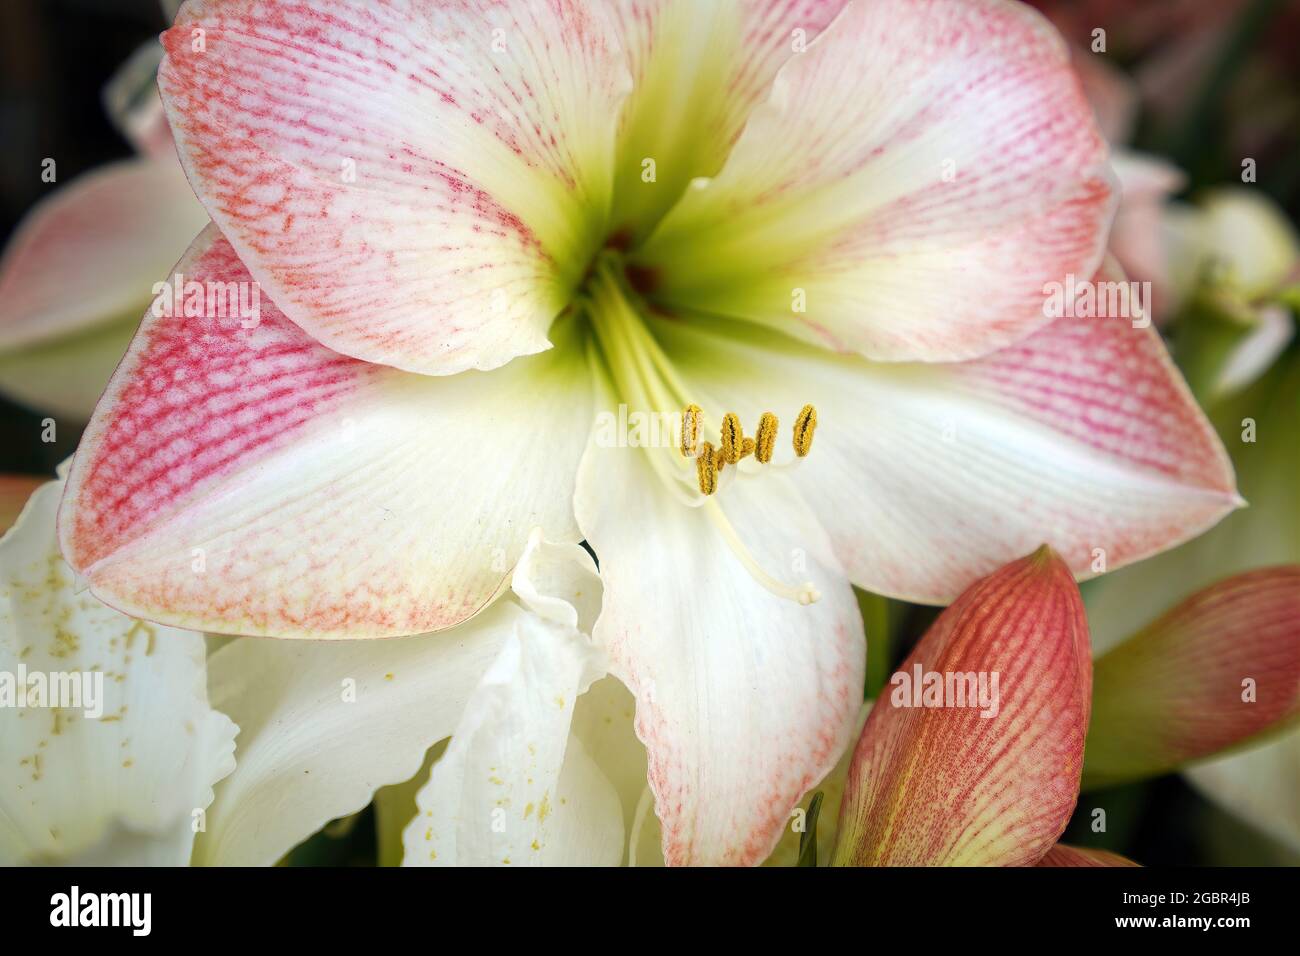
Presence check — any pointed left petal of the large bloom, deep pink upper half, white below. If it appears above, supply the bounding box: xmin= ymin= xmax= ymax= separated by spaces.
xmin=60 ymin=226 xmax=592 ymax=639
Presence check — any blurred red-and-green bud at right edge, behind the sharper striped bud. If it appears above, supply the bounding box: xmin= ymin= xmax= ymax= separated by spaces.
xmin=1087 ymin=564 xmax=1300 ymax=786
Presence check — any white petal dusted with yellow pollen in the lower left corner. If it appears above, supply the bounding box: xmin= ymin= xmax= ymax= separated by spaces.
xmin=0 ymin=481 xmax=235 ymax=866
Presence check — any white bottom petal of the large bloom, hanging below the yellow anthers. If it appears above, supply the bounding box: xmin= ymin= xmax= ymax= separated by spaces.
xmin=576 ymin=403 xmax=866 ymax=865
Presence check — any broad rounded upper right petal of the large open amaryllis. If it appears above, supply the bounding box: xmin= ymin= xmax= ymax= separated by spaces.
xmin=642 ymin=0 xmax=1113 ymax=360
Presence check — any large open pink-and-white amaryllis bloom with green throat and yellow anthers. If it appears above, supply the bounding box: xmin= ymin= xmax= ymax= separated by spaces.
xmin=60 ymin=0 xmax=1239 ymax=864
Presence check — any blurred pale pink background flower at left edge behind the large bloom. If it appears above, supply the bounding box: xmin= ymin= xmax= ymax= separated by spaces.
xmin=0 ymin=33 xmax=208 ymax=421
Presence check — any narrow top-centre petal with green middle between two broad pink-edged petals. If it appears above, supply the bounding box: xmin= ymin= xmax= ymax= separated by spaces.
xmin=602 ymin=0 xmax=846 ymax=235
